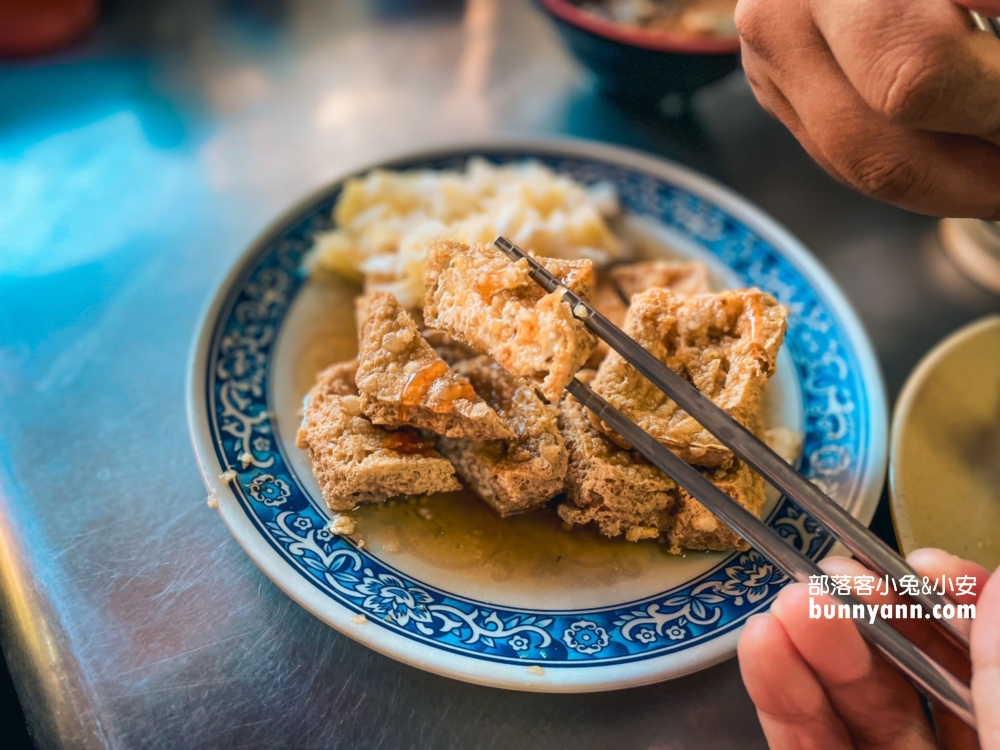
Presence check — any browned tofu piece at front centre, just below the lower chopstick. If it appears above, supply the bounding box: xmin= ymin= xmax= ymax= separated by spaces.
xmin=558 ymin=370 xmax=679 ymax=542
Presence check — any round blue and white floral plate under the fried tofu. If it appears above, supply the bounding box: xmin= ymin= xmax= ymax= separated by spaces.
xmin=188 ymin=141 xmax=886 ymax=692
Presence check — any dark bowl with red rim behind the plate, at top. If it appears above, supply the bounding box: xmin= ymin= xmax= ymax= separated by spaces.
xmin=538 ymin=0 xmax=740 ymax=110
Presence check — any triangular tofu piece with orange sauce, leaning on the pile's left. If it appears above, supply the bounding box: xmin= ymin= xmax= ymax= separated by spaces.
xmin=356 ymin=292 xmax=514 ymax=440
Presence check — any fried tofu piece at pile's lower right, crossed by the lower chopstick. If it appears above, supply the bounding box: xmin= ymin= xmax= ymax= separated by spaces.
xmin=663 ymin=459 xmax=767 ymax=555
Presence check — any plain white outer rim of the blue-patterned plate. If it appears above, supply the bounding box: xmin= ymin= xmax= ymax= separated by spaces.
xmin=186 ymin=136 xmax=889 ymax=693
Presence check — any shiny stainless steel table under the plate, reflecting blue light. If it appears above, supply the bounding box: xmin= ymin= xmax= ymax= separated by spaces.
xmin=0 ymin=0 xmax=1000 ymax=750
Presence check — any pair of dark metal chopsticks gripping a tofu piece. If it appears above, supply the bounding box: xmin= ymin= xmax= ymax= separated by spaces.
xmin=495 ymin=237 xmax=975 ymax=727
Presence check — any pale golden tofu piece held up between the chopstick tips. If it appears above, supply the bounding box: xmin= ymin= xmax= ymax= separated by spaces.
xmin=424 ymin=240 xmax=596 ymax=402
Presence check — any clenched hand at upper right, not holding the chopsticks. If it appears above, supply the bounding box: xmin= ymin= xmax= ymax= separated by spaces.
xmin=736 ymin=0 xmax=1000 ymax=220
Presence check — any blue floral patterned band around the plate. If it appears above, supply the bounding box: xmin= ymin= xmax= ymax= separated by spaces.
xmin=198 ymin=151 xmax=870 ymax=667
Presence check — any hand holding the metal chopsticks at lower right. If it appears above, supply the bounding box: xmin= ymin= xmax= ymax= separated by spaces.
xmin=738 ymin=549 xmax=1000 ymax=750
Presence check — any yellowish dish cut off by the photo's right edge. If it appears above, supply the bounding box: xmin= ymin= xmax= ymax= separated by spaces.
xmin=889 ymin=315 xmax=1000 ymax=570
